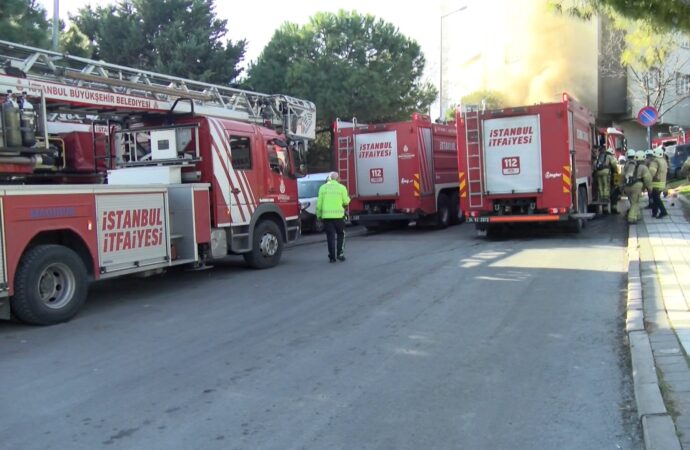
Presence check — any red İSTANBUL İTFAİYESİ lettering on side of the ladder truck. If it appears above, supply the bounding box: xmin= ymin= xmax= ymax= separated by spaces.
xmin=101 ymin=208 xmax=165 ymax=254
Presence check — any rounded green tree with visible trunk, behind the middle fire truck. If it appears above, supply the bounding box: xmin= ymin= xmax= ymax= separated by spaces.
xmin=247 ymin=10 xmax=437 ymax=169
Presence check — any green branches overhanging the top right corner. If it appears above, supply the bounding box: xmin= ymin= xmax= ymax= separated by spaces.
xmin=549 ymin=0 xmax=690 ymax=32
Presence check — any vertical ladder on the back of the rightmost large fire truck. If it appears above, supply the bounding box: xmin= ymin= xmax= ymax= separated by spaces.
xmin=464 ymin=105 xmax=484 ymax=208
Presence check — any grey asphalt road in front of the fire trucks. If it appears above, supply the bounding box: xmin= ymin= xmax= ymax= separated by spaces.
xmin=0 ymin=217 xmax=642 ymax=450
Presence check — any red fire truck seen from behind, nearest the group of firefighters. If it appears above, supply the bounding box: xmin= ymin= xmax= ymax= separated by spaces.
xmin=456 ymin=94 xmax=597 ymax=234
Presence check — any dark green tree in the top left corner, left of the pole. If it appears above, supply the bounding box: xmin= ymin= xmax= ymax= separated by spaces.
xmin=0 ymin=0 xmax=51 ymax=48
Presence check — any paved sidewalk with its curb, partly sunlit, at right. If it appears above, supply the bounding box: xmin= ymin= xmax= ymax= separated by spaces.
xmin=626 ymin=194 xmax=690 ymax=450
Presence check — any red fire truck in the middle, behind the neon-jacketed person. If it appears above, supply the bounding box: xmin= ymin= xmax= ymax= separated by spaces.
xmin=334 ymin=113 xmax=462 ymax=228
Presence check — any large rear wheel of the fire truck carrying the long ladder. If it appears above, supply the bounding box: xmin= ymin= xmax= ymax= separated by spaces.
xmin=11 ymin=245 xmax=88 ymax=325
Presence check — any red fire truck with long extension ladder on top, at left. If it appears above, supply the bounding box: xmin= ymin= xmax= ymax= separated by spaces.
xmin=0 ymin=41 xmax=315 ymax=324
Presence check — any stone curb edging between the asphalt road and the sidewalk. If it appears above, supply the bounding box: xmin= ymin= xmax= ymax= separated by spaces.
xmin=625 ymin=225 xmax=681 ymax=450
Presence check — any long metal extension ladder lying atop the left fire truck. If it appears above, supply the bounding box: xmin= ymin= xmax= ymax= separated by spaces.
xmin=0 ymin=40 xmax=316 ymax=142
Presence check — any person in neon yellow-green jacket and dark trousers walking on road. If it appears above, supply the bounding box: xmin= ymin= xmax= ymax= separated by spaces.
xmin=316 ymin=172 xmax=350 ymax=262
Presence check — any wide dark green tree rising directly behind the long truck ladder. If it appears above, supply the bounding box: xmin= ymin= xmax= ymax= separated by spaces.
xmin=70 ymin=0 xmax=246 ymax=84
